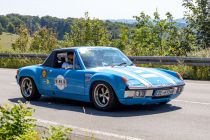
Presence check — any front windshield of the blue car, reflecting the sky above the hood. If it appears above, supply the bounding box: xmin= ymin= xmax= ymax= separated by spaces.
xmin=79 ymin=47 xmax=133 ymax=68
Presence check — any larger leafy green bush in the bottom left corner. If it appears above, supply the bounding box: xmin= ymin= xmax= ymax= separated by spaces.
xmin=0 ymin=102 xmax=36 ymax=140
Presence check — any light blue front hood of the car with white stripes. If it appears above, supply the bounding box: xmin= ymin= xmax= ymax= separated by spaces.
xmin=92 ymin=66 xmax=184 ymax=87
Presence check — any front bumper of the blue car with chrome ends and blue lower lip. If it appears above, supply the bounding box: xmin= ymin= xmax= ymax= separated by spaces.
xmin=119 ymin=85 xmax=184 ymax=105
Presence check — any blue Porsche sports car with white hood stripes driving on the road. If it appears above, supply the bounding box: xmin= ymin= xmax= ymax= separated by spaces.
xmin=16 ymin=47 xmax=185 ymax=110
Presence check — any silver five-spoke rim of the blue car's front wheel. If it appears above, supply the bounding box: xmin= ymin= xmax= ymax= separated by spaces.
xmin=94 ymin=84 xmax=110 ymax=107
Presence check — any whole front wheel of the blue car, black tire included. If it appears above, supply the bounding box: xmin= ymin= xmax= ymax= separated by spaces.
xmin=91 ymin=82 xmax=118 ymax=111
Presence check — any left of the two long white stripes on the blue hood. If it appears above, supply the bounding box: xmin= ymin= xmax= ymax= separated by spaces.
xmin=106 ymin=68 xmax=152 ymax=87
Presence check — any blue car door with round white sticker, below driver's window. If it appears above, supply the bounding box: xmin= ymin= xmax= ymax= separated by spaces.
xmin=48 ymin=52 xmax=85 ymax=98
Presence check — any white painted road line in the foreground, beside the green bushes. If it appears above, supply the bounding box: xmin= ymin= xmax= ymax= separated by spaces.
xmin=33 ymin=118 xmax=143 ymax=140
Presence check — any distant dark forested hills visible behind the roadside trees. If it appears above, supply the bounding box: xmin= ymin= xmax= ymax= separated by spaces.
xmin=0 ymin=14 xmax=186 ymax=40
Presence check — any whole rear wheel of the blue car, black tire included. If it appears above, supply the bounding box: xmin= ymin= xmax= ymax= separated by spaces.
xmin=20 ymin=77 xmax=41 ymax=101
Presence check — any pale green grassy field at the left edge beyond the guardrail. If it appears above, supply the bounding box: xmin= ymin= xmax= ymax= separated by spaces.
xmin=0 ymin=32 xmax=18 ymax=49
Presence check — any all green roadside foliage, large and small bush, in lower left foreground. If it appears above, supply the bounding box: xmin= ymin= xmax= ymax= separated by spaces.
xmin=0 ymin=102 xmax=71 ymax=140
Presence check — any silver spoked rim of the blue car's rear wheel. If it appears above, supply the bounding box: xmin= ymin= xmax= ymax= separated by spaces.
xmin=21 ymin=78 xmax=33 ymax=97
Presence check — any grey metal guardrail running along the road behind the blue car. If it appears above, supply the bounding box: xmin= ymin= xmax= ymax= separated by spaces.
xmin=0 ymin=53 xmax=210 ymax=66
